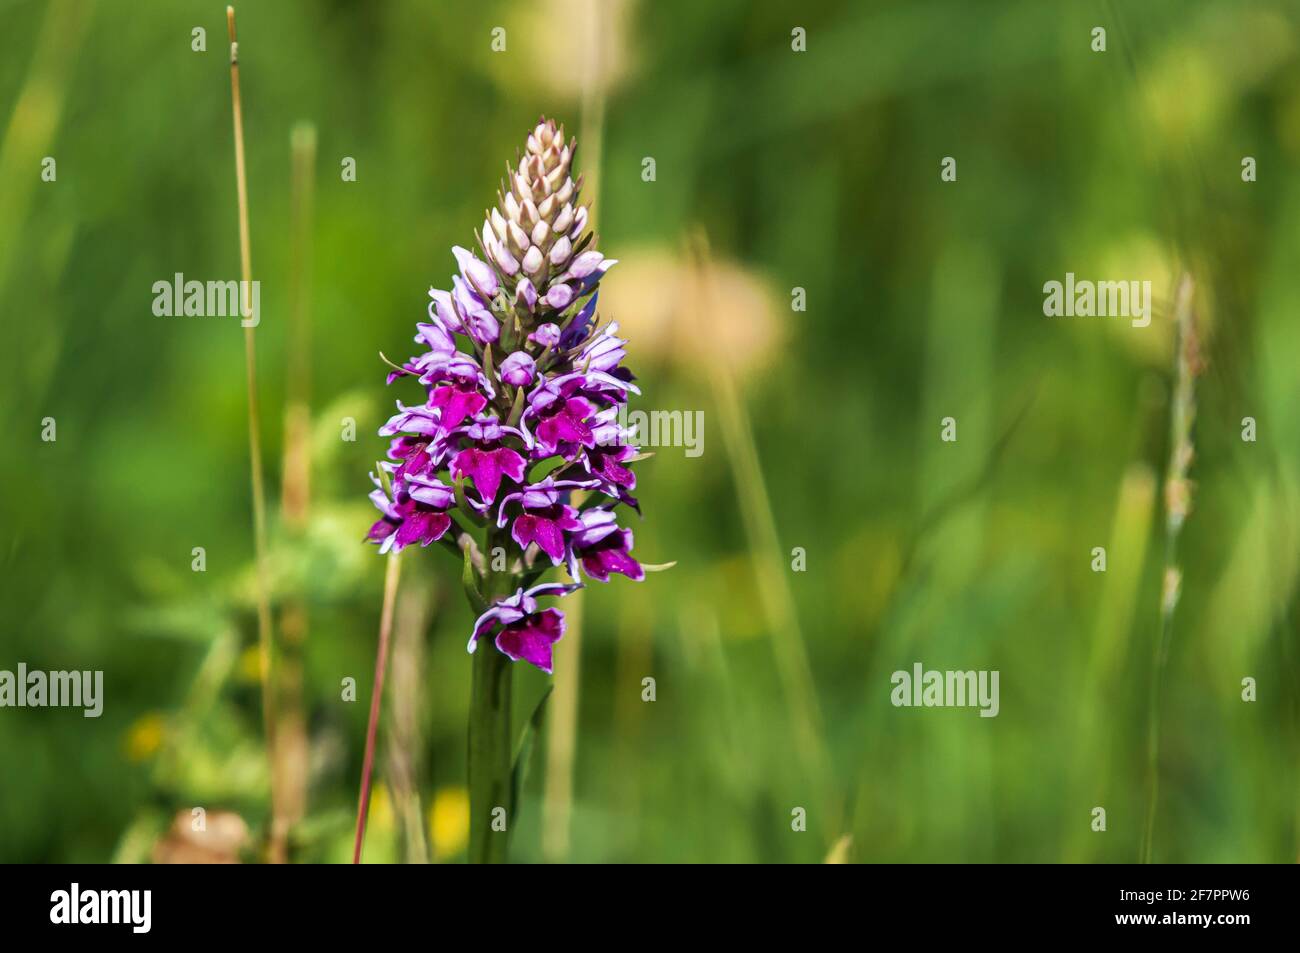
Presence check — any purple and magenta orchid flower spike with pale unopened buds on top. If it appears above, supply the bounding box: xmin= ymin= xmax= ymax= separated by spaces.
xmin=368 ymin=118 xmax=645 ymax=672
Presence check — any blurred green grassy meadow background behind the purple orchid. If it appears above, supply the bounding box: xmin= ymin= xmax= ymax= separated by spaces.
xmin=0 ymin=0 xmax=1300 ymax=862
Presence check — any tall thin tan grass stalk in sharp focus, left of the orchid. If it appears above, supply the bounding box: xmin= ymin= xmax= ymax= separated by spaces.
xmin=226 ymin=7 xmax=283 ymax=861
